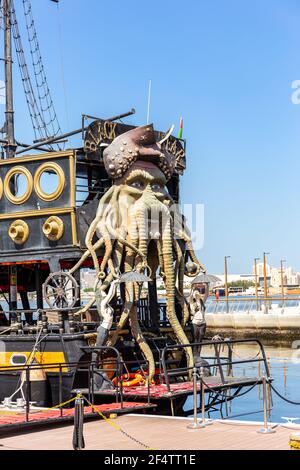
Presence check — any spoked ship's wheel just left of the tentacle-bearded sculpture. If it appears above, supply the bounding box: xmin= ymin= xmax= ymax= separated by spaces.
xmin=43 ymin=271 xmax=79 ymax=309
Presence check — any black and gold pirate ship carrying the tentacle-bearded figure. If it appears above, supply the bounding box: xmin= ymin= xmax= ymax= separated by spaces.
xmin=0 ymin=0 xmax=270 ymax=413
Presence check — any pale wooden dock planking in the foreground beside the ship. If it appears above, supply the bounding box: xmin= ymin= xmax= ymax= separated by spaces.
xmin=0 ymin=414 xmax=300 ymax=451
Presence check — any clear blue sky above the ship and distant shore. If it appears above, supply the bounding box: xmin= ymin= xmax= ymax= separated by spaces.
xmin=1 ymin=0 xmax=300 ymax=272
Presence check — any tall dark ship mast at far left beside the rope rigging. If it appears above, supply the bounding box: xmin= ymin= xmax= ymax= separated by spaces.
xmin=3 ymin=0 xmax=17 ymax=158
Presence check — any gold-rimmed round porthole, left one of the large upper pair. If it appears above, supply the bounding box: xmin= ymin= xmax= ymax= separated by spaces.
xmin=4 ymin=166 xmax=33 ymax=204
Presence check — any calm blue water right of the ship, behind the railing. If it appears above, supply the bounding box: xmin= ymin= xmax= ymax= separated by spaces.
xmin=186 ymin=346 xmax=300 ymax=424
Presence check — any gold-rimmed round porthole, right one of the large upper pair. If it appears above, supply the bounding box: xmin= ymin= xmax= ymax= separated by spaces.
xmin=34 ymin=163 xmax=65 ymax=201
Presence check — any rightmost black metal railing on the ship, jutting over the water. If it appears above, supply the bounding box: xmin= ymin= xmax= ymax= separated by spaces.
xmin=161 ymin=339 xmax=270 ymax=393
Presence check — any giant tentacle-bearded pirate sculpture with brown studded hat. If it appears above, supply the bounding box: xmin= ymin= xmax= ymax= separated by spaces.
xmin=71 ymin=125 xmax=204 ymax=380
